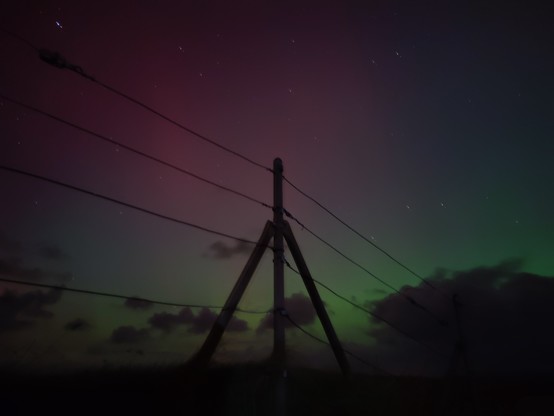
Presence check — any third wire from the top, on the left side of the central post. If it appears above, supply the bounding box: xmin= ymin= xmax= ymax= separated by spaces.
xmin=0 ymin=165 xmax=268 ymax=246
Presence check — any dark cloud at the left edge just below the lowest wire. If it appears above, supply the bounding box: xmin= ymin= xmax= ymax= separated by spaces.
xmin=0 ymin=289 xmax=62 ymax=333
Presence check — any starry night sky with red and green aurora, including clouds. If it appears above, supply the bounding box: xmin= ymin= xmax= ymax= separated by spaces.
xmin=0 ymin=1 xmax=554 ymax=373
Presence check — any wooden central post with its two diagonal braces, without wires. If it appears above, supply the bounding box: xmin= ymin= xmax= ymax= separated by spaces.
xmin=191 ymin=158 xmax=350 ymax=416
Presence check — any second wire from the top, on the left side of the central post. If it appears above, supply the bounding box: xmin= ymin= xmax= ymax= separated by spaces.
xmin=0 ymin=93 xmax=272 ymax=208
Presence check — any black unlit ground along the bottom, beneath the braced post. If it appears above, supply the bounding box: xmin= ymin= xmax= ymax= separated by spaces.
xmin=0 ymin=365 xmax=554 ymax=416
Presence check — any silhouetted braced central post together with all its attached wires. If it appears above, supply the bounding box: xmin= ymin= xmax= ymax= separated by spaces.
xmin=0 ymin=29 xmax=458 ymax=386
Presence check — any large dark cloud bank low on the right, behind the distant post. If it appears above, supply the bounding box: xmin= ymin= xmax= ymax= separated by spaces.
xmin=362 ymin=262 xmax=554 ymax=374
